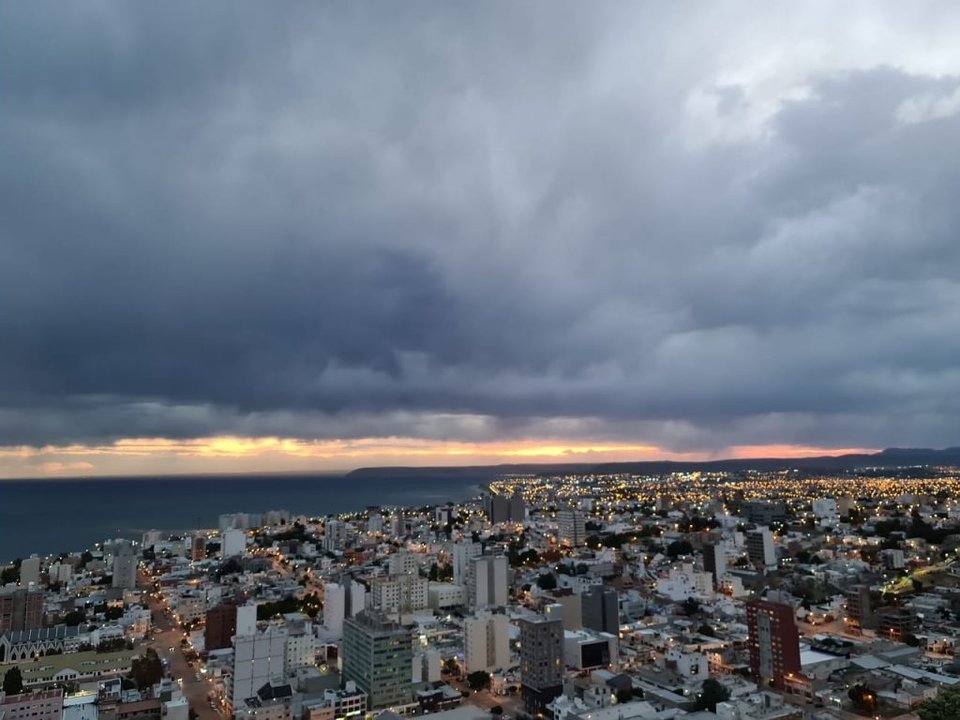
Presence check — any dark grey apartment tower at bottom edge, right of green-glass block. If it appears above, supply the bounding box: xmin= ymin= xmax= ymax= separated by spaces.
xmin=520 ymin=618 xmax=563 ymax=715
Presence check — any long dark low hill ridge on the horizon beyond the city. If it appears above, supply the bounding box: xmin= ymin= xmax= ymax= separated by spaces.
xmin=347 ymin=447 xmax=960 ymax=480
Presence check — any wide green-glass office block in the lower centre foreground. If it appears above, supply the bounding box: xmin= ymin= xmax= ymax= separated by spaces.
xmin=342 ymin=611 xmax=413 ymax=710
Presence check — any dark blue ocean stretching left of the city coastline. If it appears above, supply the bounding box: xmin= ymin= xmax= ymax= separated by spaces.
xmin=0 ymin=474 xmax=490 ymax=563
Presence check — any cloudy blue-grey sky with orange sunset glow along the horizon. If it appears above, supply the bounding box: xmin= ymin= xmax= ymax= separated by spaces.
xmin=0 ymin=0 xmax=960 ymax=477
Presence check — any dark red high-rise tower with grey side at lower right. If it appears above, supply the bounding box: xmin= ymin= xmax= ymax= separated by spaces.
xmin=747 ymin=600 xmax=801 ymax=688
